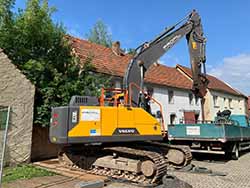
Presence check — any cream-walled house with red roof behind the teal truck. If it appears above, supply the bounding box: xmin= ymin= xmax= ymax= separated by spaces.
xmin=176 ymin=65 xmax=248 ymax=120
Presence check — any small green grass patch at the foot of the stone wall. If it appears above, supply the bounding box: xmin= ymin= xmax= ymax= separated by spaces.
xmin=3 ymin=165 xmax=55 ymax=183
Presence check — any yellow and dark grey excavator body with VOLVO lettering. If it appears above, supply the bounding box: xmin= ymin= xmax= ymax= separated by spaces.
xmin=50 ymin=97 xmax=163 ymax=144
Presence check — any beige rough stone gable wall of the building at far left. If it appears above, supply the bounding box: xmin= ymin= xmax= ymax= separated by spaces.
xmin=0 ymin=49 xmax=35 ymax=164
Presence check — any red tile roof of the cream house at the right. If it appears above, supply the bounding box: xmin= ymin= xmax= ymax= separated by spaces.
xmin=176 ymin=65 xmax=245 ymax=97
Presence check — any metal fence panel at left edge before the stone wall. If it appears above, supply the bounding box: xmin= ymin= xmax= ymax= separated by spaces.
xmin=0 ymin=107 xmax=10 ymax=188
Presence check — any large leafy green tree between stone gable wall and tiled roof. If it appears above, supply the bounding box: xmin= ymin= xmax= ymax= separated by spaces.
xmin=0 ymin=0 xmax=108 ymax=126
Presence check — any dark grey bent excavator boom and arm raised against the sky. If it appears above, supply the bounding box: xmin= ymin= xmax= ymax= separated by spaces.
xmin=123 ymin=10 xmax=208 ymax=106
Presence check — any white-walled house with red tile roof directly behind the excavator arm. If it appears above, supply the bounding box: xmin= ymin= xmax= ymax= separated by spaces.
xmin=67 ymin=36 xmax=248 ymax=124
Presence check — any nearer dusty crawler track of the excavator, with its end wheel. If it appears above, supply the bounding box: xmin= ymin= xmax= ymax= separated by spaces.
xmin=58 ymin=147 xmax=167 ymax=186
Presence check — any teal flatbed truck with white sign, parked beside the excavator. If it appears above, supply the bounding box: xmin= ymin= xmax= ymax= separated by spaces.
xmin=168 ymin=113 xmax=250 ymax=160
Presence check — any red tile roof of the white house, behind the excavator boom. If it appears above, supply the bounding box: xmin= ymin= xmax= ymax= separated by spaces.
xmin=67 ymin=36 xmax=192 ymax=89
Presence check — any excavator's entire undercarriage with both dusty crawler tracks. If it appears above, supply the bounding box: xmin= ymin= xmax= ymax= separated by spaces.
xmin=59 ymin=142 xmax=192 ymax=186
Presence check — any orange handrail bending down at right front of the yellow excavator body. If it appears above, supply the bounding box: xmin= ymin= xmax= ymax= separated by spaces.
xmin=129 ymin=82 xmax=166 ymax=137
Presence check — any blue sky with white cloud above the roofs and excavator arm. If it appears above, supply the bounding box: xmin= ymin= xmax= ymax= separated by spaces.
xmin=15 ymin=0 xmax=250 ymax=95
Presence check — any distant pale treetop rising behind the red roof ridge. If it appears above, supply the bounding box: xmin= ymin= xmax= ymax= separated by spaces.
xmin=86 ymin=20 xmax=112 ymax=47
